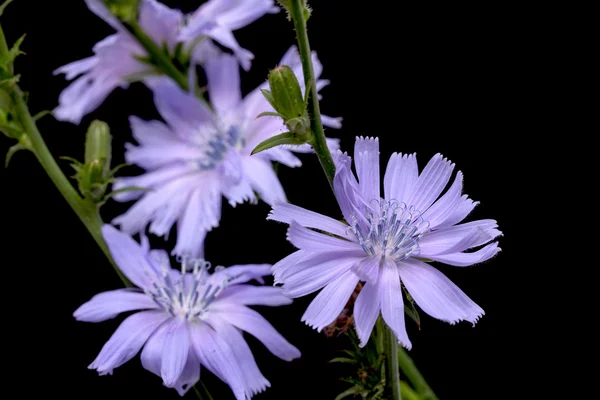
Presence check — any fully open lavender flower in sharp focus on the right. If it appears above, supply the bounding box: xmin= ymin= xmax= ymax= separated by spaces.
xmin=268 ymin=138 xmax=501 ymax=348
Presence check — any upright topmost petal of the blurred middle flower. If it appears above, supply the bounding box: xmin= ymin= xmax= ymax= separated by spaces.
xmin=204 ymin=54 xmax=242 ymax=116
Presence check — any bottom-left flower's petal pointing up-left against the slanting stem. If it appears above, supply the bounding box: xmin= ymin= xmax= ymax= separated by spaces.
xmin=102 ymin=224 xmax=159 ymax=289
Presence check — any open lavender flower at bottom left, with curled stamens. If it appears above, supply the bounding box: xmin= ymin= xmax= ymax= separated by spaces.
xmin=74 ymin=225 xmax=300 ymax=400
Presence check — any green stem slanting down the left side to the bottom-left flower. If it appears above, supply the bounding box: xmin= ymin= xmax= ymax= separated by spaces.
xmin=8 ymin=83 xmax=131 ymax=286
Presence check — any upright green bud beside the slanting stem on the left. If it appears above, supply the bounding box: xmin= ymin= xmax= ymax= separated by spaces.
xmin=84 ymin=120 xmax=112 ymax=177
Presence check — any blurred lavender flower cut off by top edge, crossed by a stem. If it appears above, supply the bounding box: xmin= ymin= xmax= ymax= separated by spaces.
xmin=54 ymin=0 xmax=276 ymax=124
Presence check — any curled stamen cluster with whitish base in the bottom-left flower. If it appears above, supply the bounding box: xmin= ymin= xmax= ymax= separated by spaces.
xmin=145 ymin=258 xmax=233 ymax=321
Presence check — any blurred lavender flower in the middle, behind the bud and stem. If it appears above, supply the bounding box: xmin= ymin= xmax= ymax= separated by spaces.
xmin=114 ymin=48 xmax=339 ymax=257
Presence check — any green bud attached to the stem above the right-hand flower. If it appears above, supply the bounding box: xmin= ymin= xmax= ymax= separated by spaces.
xmin=269 ymin=65 xmax=306 ymax=120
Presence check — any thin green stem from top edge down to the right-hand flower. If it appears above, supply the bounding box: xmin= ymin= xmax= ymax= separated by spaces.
xmin=290 ymin=0 xmax=335 ymax=187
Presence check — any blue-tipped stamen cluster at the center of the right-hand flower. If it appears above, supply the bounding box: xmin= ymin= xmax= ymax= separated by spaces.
xmin=351 ymin=199 xmax=429 ymax=261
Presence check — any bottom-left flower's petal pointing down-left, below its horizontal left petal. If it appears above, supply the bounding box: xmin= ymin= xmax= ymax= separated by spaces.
xmin=88 ymin=311 xmax=171 ymax=375
